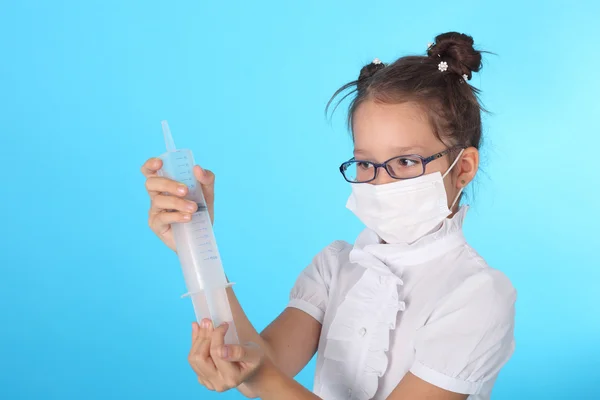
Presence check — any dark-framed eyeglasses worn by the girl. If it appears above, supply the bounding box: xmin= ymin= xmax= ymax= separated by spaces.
xmin=340 ymin=148 xmax=462 ymax=183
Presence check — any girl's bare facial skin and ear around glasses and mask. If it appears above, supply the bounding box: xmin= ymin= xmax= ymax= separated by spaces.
xmin=353 ymin=100 xmax=479 ymax=211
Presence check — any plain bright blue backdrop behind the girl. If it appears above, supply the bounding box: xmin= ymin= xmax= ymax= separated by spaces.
xmin=0 ymin=0 xmax=600 ymax=400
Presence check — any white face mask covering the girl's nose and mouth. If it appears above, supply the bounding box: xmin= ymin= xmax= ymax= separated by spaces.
xmin=346 ymin=150 xmax=464 ymax=243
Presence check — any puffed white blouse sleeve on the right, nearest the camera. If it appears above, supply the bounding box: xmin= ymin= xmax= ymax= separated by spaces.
xmin=410 ymin=269 xmax=516 ymax=394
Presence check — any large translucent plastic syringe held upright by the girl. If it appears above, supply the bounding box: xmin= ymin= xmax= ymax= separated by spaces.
xmin=159 ymin=121 xmax=239 ymax=344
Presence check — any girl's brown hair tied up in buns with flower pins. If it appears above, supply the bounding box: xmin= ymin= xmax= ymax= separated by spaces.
xmin=325 ymin=32 xmax=485 ymax=153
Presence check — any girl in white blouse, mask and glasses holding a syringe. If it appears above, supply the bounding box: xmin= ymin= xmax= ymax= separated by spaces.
xmin=142 ymin=32 xmax=516 ymax=400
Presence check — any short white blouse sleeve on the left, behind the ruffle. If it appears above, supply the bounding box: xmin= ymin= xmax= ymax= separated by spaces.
xmin=288 ymin=241 xmax=344 ymax=324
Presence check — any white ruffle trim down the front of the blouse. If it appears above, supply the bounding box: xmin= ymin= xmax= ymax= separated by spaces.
xmin=318 ymin=268 xmax=405 ymax=400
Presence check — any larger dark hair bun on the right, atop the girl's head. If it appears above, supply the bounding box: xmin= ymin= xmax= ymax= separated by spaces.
xmin=427 ymin=32 xmax=482 ymax=79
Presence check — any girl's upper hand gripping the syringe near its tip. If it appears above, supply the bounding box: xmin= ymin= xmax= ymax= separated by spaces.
xmin=142 ymin=158 xmax=215 ymax=251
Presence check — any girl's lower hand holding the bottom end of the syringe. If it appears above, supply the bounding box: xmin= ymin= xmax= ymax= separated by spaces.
xmin=188 ymin=319 xmax=264 ymax=398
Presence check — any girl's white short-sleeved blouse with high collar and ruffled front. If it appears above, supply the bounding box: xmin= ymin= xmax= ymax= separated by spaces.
xmin=289 ymin=206 xmax=516 ymax=400
